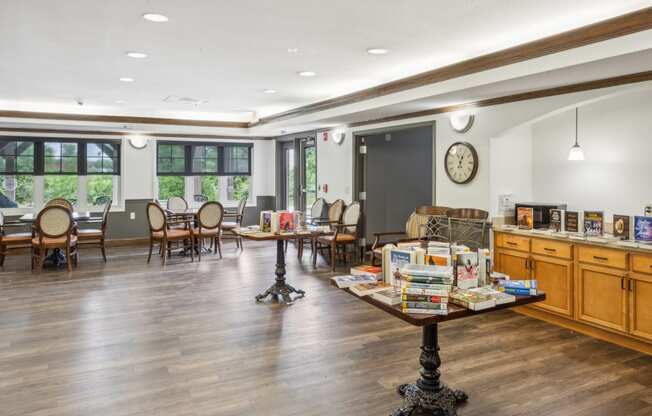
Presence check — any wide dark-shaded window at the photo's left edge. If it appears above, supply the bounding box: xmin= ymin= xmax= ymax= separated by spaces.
xmin=0 ymin=137 xmax=120 ymax=210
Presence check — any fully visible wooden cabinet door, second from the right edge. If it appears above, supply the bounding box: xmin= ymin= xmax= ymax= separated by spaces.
xmin=576 ymin=264 xmax=627 ymax=332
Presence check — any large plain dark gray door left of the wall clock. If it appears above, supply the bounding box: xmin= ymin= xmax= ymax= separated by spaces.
xmin=364 ymin=126 xmax=433 ymax=240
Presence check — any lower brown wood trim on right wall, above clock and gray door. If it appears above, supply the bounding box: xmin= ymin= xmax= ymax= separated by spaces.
xmin=347 ymin=71 xmax=652 ymax=127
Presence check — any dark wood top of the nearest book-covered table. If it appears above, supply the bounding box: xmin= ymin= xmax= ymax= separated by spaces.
xmin=344 ymin=289 xmax=546 ymax=326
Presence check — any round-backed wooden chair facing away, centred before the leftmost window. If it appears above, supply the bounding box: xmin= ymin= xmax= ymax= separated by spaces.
xmin=32 ymin=204 xmax=79 ymax=273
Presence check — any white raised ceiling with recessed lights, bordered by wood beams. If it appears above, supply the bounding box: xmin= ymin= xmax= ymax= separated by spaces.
xmin=0 ymin=0 xmax=652 ymax=121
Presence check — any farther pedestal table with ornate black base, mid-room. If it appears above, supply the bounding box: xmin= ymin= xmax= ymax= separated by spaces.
xmin=233 ymin=228 xmax=329 ymax=305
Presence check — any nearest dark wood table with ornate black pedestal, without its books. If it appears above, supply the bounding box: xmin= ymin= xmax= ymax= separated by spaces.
xmin=345 ymin=289 xmax=546 ymax=416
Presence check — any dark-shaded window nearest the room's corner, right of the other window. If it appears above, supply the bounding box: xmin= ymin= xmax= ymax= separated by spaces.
xmin=156 ymin=142 xmax=252 ymax=205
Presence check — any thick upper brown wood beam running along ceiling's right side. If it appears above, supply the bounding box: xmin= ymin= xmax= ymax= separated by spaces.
xmin=250 ymin=7 xmax=652 ymax=127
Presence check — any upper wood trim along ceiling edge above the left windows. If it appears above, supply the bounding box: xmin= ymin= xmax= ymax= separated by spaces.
xmin=0 ymin=110 xmax=250 ymax=129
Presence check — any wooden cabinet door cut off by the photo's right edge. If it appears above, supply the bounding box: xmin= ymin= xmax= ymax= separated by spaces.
xmin=628 ymin=275 xmax=652 ymax=341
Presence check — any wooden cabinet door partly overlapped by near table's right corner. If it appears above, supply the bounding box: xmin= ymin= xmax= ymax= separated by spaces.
xmin=531 ymin=256 xmax=573 ymax=317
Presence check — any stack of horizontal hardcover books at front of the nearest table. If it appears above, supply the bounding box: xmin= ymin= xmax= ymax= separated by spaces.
xmin=401 ymin=264 xmax=453 ymax=315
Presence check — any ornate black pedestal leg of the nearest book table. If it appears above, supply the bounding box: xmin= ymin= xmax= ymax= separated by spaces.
xmin=392 ymin=324 xmax=468 ymax=416
